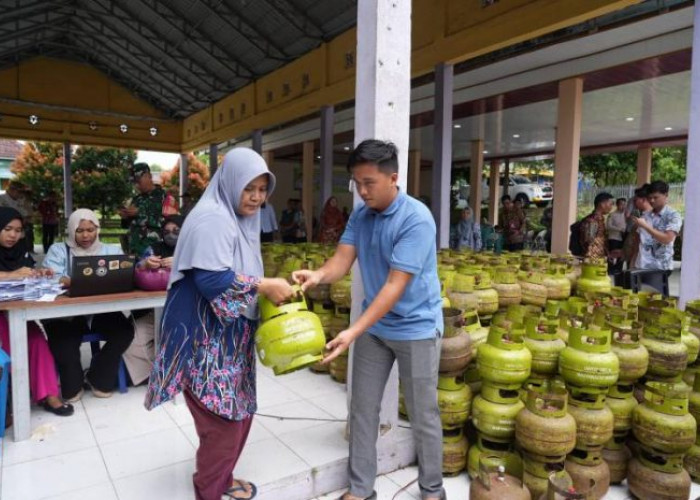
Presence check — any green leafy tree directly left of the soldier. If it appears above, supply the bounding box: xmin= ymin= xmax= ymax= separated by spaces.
xmin=71 ymin=146 xmax=136 ymax=217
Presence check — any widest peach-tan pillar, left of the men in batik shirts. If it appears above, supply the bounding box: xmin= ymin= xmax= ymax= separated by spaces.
xmin=552 ymin=77 xmax=583 ymax=254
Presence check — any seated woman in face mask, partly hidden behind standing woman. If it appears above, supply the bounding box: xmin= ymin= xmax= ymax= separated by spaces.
xmin=124 ymin=215 xmax=184 ymax=385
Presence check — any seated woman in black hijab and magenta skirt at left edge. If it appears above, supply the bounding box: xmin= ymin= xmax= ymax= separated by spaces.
xmin=0 ymin=207 xmax=73 ymax=417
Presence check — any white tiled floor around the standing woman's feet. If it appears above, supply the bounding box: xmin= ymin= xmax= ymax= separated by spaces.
xmin=0 ymin=360 xmax=700 ymax=500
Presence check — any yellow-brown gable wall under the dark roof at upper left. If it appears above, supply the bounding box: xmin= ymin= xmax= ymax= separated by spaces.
xmin=0 ymin=57 xmax=183 ymax=151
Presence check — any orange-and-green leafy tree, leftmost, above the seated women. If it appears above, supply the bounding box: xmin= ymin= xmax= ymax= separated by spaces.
xmin=10 ymin=142 xmax=63 ymax=205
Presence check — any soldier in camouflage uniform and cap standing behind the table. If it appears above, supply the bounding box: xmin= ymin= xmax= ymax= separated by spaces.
xmin=119 ymin=163 xmax=166 ymax=256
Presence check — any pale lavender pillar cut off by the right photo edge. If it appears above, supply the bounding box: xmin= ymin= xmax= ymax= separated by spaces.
xmin=680 ymin=8 xmax=700 ymax=308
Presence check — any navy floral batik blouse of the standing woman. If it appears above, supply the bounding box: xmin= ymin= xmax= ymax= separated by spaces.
xmin=145 ymin=269 xmax=260 ymax=420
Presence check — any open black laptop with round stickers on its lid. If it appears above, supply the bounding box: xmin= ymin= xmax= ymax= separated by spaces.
xmin=68 ymin=255 xmax=135 ymax=297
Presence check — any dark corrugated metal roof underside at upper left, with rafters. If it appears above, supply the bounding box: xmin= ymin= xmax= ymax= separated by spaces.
xmin=0 ymin=0 xmax=357 ymax=118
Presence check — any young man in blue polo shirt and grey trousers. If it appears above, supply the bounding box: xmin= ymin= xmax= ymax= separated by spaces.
xmin=293 ymin=140 xmax=446 ymax=500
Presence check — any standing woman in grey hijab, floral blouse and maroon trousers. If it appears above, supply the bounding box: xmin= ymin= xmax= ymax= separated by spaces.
xmin=145 ymin=148 xmax=292 ymax=500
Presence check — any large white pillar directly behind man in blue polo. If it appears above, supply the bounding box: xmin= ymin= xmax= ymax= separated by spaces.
xmin=348 ymin=0 xmax=411 ymax=473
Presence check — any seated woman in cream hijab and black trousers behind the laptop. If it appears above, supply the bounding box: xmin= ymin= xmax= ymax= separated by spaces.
xmin=44 ymin=208 xmax=134 ymax=403
